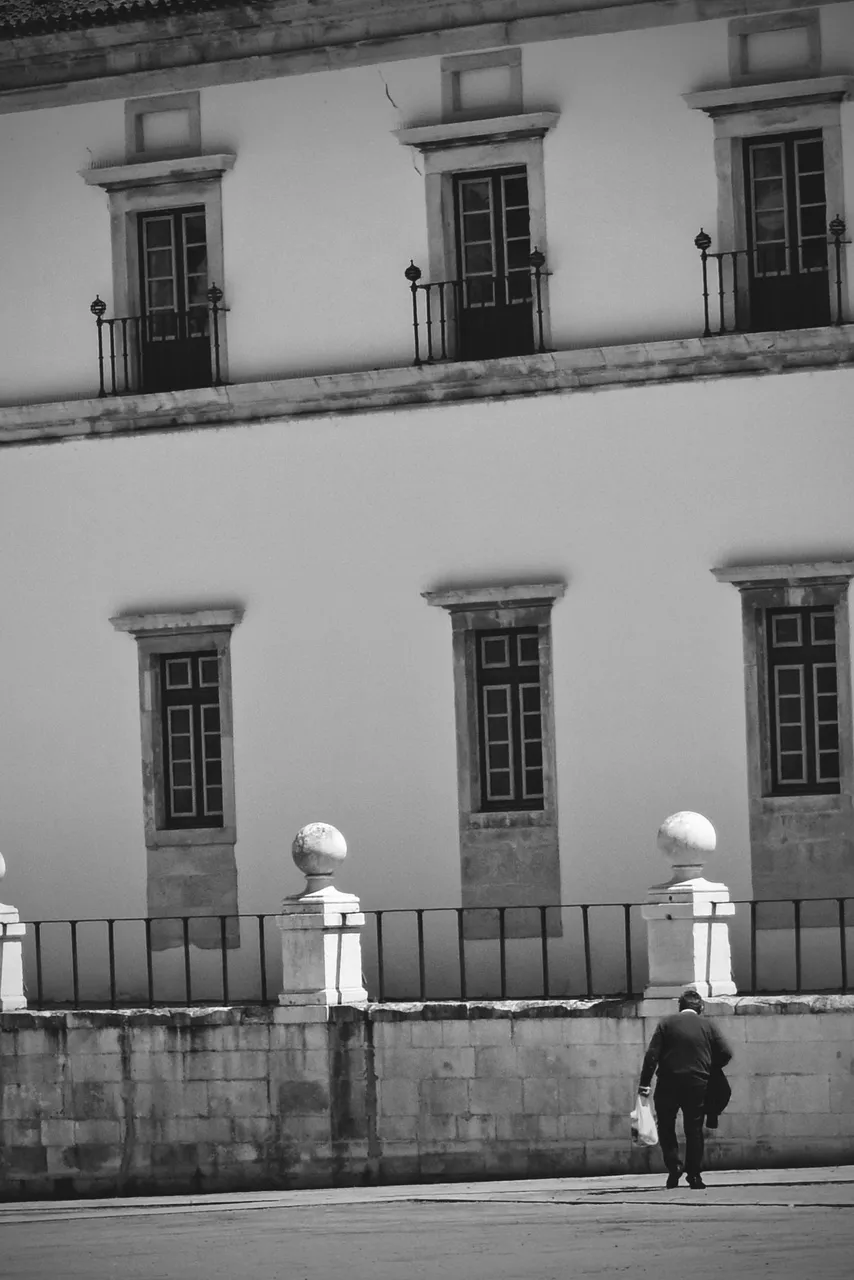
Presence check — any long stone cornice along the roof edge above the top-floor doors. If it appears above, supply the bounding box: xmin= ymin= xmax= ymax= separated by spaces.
xmin=0 ymin=0 xmax=842 ymax=111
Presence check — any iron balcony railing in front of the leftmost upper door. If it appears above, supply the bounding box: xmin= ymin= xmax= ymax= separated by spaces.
xmin=90 ymin=284 xmax=224 ymax=396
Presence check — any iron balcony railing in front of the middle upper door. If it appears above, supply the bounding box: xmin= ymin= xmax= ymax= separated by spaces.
xmin=403 ymin=250 xmax=547 ymax=365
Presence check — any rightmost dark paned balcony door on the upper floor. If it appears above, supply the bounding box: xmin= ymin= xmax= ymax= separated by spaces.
xmin=744 ymin=132 xmax=830 ymax=330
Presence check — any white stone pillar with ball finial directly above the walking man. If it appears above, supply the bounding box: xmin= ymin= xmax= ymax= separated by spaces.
xmin=641 ymin=813 xmax=736 ymax=1012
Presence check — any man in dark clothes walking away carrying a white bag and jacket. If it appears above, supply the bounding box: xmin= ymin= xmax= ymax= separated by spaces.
xmin=639 ymin=988 xmax=732 ymax=1190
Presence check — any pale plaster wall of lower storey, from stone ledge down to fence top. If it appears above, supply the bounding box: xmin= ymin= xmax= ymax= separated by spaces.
xmin=0 ymin=371 xmax=854 ymax=947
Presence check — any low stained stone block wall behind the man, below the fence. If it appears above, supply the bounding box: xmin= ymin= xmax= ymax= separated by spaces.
xmin=0 ymin=997 xmax=854 ymax=1198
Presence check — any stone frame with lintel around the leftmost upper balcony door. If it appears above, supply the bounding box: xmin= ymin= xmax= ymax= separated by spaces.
xmin=81 ymin=152 xmax=237 ymax=383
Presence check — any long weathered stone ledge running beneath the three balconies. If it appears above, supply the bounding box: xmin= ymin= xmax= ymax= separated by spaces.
xmin=0 ymin=325 xmax=854 ymax=445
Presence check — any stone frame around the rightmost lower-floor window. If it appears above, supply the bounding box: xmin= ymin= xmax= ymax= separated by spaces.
xmin=712 ymin=559 xmax=854 ymax=813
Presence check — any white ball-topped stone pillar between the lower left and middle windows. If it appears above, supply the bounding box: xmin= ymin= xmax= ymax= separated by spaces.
xmin=275 ymin=822 xmax=367 ymax=1021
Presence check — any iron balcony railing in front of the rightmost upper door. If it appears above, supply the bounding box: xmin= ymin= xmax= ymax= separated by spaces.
xmin=694 ymin=218 xmax=850 ymax=338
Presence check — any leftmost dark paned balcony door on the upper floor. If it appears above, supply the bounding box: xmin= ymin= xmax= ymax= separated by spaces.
xmin=140 ymin=209 xmax=211 ymax=390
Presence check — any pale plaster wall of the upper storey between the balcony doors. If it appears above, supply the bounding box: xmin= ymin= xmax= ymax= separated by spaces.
xmin=0 ymin=4 xmax=854 ymax=403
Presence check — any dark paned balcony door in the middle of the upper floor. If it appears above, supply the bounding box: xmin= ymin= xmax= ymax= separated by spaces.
xmin=453 ymin=168 xmax=534 ymax=360
